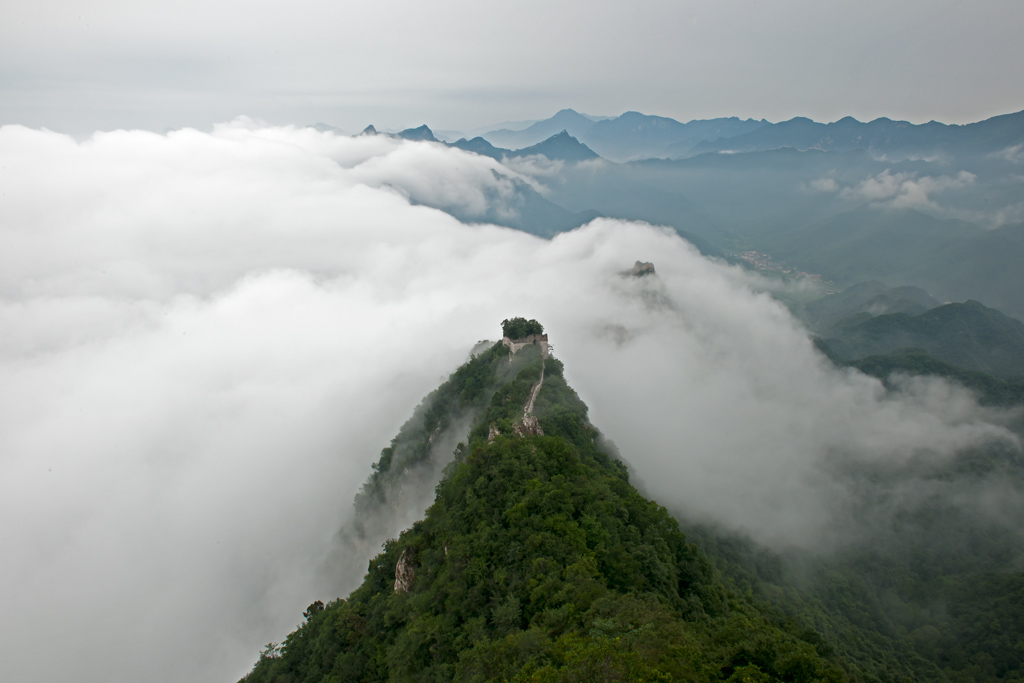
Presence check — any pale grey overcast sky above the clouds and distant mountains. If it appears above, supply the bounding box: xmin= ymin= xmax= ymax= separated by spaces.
xmin=0 ymin=0 xmax=1024 ymax=134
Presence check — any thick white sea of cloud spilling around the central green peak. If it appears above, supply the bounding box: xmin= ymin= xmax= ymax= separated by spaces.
xmin=0 ymin=121 xmax=1016 ymax=681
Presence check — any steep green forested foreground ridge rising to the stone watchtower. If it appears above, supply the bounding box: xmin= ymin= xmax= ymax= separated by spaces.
xmin=244 ymin=329 xmax=845 ymax=683
